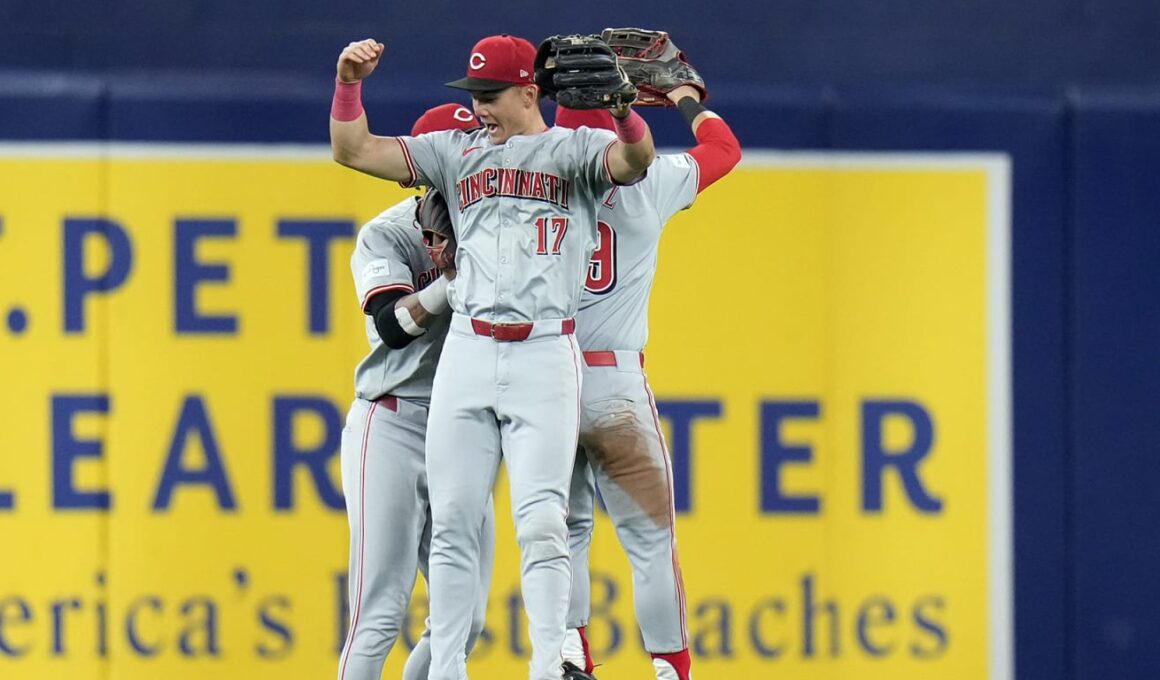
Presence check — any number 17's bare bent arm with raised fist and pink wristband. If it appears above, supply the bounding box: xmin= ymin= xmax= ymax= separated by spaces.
xmin=331 ymin=39 xmax=412 ymax=182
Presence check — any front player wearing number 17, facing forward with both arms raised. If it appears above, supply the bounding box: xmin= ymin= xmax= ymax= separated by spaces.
xmin=331 ymin=35 xmax=654 ymax=680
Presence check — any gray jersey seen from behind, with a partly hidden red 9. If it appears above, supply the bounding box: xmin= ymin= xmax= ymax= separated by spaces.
xmin=577 ymin=153 xmax=699 ymax=352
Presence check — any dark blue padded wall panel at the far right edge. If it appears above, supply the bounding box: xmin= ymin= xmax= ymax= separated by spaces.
xmin=1070 ymin=89 xmax=1160 ymax=679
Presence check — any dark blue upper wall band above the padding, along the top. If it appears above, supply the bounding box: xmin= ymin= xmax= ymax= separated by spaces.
xmin=0 ymin=0 xmax=1160 ymax=85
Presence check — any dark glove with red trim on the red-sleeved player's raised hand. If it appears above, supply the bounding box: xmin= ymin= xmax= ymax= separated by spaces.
xmin=600 ymin=28 xmax=709 ymax=107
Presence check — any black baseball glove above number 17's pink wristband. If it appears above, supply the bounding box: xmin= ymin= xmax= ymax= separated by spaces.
xmin=535 ymin=35 xmax=637 ymax=109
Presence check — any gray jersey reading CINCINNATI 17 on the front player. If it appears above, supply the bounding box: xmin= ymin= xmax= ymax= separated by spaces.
xmin=399 ymin=128 xmax=615 ymax=323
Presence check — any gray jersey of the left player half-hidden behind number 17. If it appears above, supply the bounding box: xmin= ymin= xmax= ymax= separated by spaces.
xmin=350 ymin=197 xmax=451 ymax=404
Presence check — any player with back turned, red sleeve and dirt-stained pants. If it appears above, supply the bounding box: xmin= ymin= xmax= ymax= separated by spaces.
xmin=556 ymin=76 xmax=741 ymax=680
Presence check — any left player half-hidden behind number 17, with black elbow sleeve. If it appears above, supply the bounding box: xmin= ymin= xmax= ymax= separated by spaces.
xmin=339 ymin=103 xmax=494 ymax=680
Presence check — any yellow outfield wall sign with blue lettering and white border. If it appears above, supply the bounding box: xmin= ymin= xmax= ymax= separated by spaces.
xmin=0 ymin=146 xmax=1013 ymax=680
